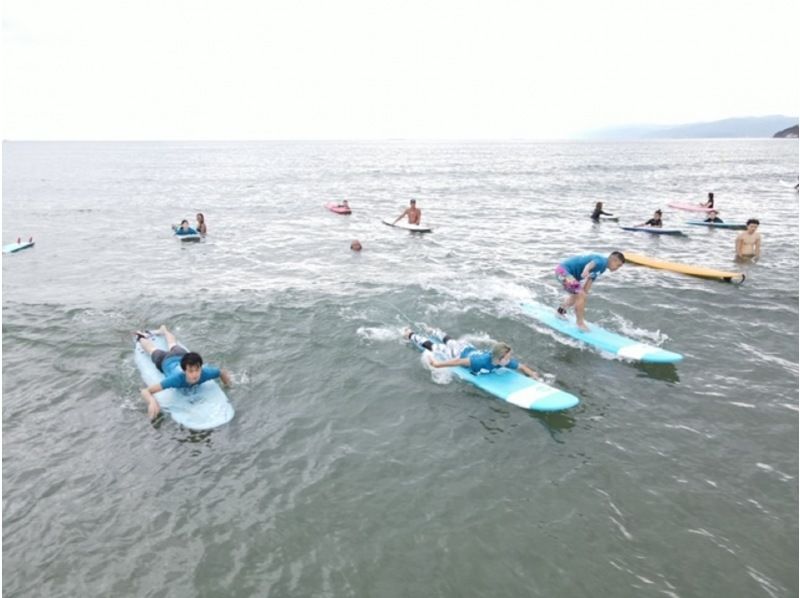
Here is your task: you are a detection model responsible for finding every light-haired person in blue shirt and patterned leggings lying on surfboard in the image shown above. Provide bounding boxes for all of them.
[403,328,542,380]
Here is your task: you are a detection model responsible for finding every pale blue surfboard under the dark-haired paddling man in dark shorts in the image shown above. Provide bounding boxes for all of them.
[133,334,233,430]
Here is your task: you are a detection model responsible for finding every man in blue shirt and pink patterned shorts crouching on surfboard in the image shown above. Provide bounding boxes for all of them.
[556,251,625,332]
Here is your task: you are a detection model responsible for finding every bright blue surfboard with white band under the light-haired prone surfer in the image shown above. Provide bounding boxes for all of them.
[412,336,580,412]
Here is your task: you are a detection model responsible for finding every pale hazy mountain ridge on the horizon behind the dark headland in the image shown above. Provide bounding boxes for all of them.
[583,115,798,140]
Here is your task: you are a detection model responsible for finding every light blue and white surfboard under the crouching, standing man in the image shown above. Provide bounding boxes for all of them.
[522,300,683,364]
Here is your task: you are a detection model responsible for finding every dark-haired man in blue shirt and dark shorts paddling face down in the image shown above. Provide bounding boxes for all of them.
[135,324,231,420]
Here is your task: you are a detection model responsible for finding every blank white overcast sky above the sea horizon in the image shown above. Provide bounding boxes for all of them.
[2,0,800,139]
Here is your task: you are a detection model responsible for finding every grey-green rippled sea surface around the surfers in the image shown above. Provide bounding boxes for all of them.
[2,139,798,598]
